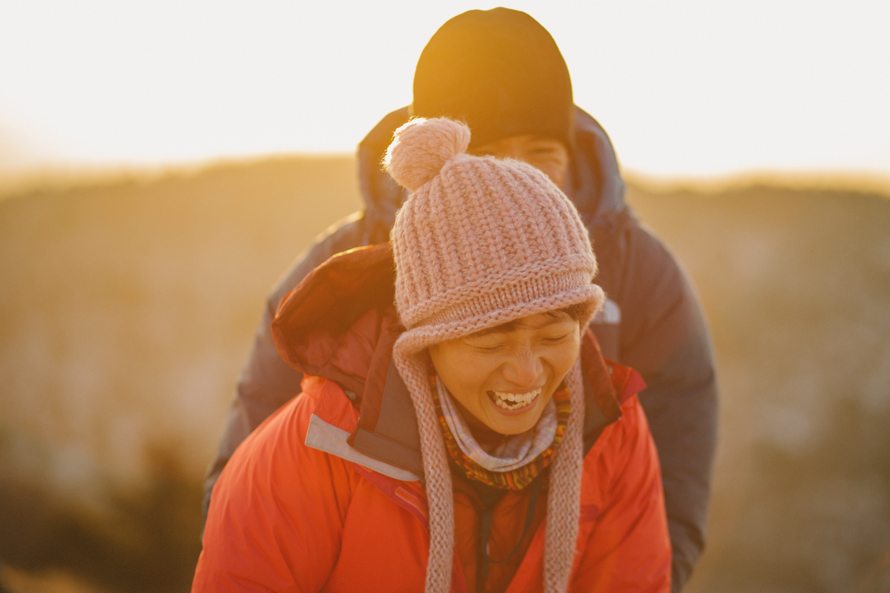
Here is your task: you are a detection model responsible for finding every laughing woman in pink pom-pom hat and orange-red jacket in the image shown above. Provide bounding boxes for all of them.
[193,118,670,593]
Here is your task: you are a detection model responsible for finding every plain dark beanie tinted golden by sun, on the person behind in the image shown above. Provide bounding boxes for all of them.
[411,8,573,150]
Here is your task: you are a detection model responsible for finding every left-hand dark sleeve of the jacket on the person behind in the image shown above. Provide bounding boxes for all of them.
[202,213,369,519]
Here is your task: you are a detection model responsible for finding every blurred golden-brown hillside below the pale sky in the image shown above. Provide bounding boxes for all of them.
[0,158,890,593]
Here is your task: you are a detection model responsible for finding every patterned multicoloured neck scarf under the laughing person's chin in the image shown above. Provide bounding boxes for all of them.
[430,376,572,490]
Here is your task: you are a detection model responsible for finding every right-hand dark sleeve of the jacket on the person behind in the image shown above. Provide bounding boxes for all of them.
[619,221,717,593]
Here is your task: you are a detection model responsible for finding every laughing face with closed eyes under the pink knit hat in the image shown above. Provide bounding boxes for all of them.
[429,311,581,435]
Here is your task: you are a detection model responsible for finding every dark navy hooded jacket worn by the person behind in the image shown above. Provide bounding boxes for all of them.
[204,108,717,593]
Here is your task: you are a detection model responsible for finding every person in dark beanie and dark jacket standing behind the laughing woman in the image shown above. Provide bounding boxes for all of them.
[205,8,717,592]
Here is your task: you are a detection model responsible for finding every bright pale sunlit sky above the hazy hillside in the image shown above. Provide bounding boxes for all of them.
[0,0,890,177]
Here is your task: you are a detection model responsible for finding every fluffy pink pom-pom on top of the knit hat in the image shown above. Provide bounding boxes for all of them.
[383,117,470,192]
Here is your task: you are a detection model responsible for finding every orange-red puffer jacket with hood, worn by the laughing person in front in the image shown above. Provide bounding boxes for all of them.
[192,247,671,593]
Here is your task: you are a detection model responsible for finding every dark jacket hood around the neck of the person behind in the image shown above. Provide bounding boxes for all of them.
[356,106,625,231]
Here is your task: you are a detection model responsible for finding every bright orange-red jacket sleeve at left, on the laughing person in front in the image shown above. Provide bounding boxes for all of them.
[192,388,356,593]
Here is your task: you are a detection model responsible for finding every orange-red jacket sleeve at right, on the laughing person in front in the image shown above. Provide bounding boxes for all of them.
[572,397,671,593]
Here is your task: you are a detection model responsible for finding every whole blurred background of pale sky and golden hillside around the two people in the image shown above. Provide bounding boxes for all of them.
[0,0,890,593]
